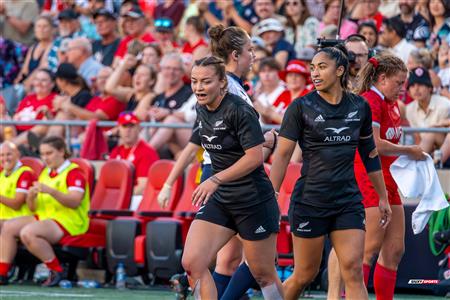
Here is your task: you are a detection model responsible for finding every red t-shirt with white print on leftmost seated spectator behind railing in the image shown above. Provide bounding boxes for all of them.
[14,93,56,131]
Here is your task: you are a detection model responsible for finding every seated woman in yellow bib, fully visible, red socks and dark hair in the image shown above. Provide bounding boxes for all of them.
[0,137,90,287]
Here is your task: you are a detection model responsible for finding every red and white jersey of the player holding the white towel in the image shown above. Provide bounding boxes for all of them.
[361,86,402,169]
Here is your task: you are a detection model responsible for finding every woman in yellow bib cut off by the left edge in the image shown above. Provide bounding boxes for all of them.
[0,142,35,231]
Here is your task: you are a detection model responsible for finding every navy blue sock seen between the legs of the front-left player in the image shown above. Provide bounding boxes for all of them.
[219,262,258,300]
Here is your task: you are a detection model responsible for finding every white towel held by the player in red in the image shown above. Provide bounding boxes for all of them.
[390,154,449,234]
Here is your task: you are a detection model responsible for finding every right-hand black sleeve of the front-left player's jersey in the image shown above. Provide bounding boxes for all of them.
[234,103,264,150]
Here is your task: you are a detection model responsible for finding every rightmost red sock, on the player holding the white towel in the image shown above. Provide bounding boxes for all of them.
[373,263,397,300]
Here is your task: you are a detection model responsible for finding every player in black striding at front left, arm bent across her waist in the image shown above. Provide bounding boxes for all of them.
[182,56,282,299]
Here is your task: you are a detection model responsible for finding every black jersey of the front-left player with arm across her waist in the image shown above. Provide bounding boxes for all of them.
[191,93,274,208]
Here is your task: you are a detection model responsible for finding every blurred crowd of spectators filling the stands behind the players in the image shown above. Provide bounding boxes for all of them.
[0,0,450,173]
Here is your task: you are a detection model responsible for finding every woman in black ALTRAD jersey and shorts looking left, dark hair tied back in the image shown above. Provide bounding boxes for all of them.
[270,47,390,299]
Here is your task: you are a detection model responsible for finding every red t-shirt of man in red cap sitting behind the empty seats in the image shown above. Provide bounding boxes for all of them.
[110,140,159,178]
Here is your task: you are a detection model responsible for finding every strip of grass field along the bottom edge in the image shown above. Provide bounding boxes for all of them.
[0,285,443,300]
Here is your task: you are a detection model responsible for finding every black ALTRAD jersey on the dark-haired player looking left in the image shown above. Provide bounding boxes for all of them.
[280,91,373,207]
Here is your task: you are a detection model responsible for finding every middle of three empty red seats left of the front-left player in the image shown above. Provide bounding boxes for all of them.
[102,159,183,276]
